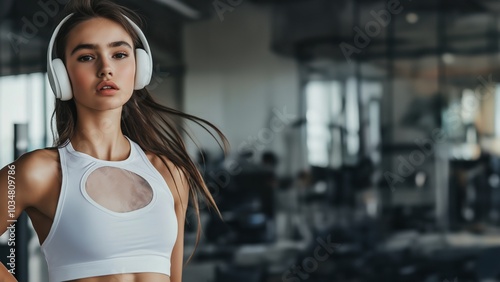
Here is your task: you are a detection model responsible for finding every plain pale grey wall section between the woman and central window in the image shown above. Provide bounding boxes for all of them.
[184,2,299,173]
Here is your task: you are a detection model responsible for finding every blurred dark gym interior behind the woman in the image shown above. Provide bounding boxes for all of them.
[0,0,500,282]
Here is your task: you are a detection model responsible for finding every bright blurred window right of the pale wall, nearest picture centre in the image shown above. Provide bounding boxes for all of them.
[305,78,382,168]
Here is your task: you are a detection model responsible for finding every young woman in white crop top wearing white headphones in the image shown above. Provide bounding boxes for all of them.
[0,0,227,282]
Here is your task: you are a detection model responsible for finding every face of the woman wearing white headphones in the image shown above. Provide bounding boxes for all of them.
[65,18,135,111]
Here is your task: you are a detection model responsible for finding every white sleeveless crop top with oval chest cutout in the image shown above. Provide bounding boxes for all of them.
[41,137,177,282]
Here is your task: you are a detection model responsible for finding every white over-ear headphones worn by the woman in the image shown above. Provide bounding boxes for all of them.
[47,14,153,101]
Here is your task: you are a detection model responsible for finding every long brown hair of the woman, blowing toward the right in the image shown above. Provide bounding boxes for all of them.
[48,0,229,261]
